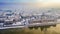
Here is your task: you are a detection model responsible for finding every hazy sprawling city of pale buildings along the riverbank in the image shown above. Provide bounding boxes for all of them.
[0,8,60,29]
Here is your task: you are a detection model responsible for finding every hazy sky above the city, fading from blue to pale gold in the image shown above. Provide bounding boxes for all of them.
[0,0,60,8]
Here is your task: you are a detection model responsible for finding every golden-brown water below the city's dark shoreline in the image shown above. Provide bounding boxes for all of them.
[0,24,60,34]
